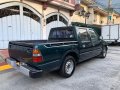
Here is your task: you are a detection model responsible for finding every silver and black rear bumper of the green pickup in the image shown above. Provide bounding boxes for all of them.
[6,58,43,78]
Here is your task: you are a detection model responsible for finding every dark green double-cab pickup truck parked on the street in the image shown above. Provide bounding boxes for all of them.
[6,26,108,78]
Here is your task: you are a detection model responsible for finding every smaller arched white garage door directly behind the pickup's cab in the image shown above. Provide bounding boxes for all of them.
[46,13,68,39]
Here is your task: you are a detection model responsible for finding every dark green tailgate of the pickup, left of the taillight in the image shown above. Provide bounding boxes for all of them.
[9,42,33,63]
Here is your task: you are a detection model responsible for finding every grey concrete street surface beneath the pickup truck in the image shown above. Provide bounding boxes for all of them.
[0,46,120,90]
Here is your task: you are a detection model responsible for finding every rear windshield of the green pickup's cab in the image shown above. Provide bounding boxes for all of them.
[49,28,75,39]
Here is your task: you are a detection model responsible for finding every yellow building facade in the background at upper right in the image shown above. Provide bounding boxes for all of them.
[72,0,120,26]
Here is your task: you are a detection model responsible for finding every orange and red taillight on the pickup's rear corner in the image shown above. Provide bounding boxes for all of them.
[33,49,43,63]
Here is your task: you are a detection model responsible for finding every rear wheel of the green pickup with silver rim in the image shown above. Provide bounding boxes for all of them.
[59,56,76,78]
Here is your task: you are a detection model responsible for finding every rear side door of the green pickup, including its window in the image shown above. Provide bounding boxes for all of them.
[77,28,93,61]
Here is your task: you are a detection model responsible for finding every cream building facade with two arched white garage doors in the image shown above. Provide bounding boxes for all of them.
[0,0,75,49]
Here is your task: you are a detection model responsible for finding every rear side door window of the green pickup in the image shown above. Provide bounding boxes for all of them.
[78,28,90,43]
